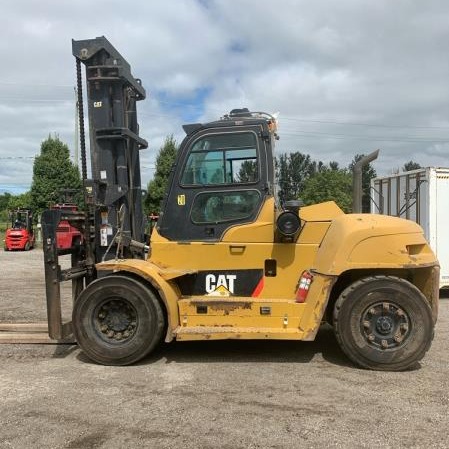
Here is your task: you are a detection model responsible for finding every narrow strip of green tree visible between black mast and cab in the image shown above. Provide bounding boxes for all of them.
[144,135,178,215]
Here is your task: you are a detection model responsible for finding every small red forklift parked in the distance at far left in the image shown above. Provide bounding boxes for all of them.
[5,209,36,251]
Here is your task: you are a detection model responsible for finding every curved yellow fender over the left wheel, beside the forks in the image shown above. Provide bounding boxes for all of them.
[96,259,186,343]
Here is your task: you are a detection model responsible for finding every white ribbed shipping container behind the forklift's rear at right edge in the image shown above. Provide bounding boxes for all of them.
[370,167,449,288]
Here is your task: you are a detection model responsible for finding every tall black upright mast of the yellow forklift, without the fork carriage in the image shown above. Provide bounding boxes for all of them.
[72,37,148,262]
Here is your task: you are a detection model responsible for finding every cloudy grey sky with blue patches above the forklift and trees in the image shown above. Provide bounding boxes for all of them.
[0,0,449,193]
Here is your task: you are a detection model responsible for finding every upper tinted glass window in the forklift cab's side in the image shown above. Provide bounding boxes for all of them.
[181,132,259,186]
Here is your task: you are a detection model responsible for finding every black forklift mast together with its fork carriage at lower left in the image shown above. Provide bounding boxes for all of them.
[42,36,148,339]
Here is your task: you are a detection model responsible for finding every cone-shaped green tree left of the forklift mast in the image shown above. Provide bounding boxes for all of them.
[30,136,82,217]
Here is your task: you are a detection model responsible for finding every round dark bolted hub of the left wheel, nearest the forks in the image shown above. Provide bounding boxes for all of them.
[95,299,137,341]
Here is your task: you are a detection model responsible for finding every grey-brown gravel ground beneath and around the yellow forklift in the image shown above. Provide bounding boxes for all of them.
[0,250,449,449]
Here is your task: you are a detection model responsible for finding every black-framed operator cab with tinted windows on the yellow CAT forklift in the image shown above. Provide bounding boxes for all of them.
[157,109,275,241]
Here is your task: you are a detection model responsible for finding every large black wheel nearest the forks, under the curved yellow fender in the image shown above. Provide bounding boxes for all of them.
[72,276,165,365]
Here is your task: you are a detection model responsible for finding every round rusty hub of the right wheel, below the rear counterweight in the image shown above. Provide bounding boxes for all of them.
[361,301,410,349]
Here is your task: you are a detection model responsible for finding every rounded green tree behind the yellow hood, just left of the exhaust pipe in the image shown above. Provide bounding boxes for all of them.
[301,169,352,212]
